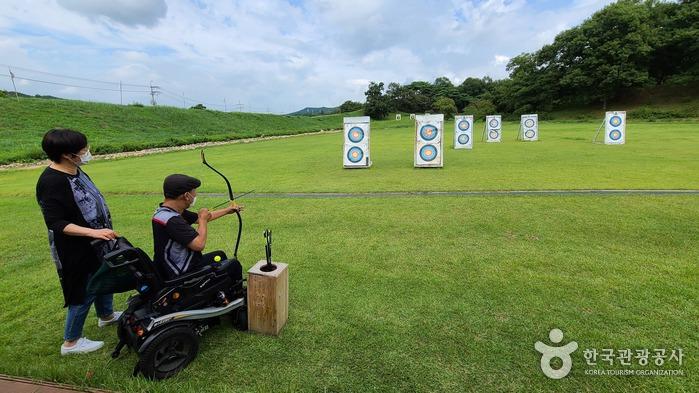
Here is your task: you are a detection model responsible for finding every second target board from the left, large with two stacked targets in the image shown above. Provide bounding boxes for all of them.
[414,115,444,168]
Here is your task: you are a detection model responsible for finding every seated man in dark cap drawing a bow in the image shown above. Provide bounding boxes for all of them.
[152,174,242,280]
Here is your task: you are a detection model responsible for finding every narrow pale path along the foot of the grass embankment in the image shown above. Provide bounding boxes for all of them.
[0,129,341,171]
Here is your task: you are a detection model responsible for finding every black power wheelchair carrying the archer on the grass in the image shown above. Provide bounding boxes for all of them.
[88,237,247,379]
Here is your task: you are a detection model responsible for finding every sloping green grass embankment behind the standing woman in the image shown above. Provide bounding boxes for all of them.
[0,97,342,164]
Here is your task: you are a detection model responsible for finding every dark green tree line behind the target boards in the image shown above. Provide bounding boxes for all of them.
[348,0,699,119]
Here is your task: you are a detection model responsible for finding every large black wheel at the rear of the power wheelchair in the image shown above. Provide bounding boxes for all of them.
[139,327,199,379]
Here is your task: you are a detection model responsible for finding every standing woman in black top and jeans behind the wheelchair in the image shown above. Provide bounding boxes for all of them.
[36,128,121,355]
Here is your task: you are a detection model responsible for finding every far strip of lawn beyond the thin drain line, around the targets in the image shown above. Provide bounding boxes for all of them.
[0,116,699,196]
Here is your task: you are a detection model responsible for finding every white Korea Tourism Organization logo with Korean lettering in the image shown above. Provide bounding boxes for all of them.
[534,328,685,379]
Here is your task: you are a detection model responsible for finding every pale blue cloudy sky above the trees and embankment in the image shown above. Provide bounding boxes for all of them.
[0,0,611,113]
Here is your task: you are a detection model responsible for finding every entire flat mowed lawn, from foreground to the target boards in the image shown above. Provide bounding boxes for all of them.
[0,121,699,392]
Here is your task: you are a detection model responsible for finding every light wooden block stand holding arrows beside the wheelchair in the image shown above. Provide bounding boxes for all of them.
[248,260,289,336]
